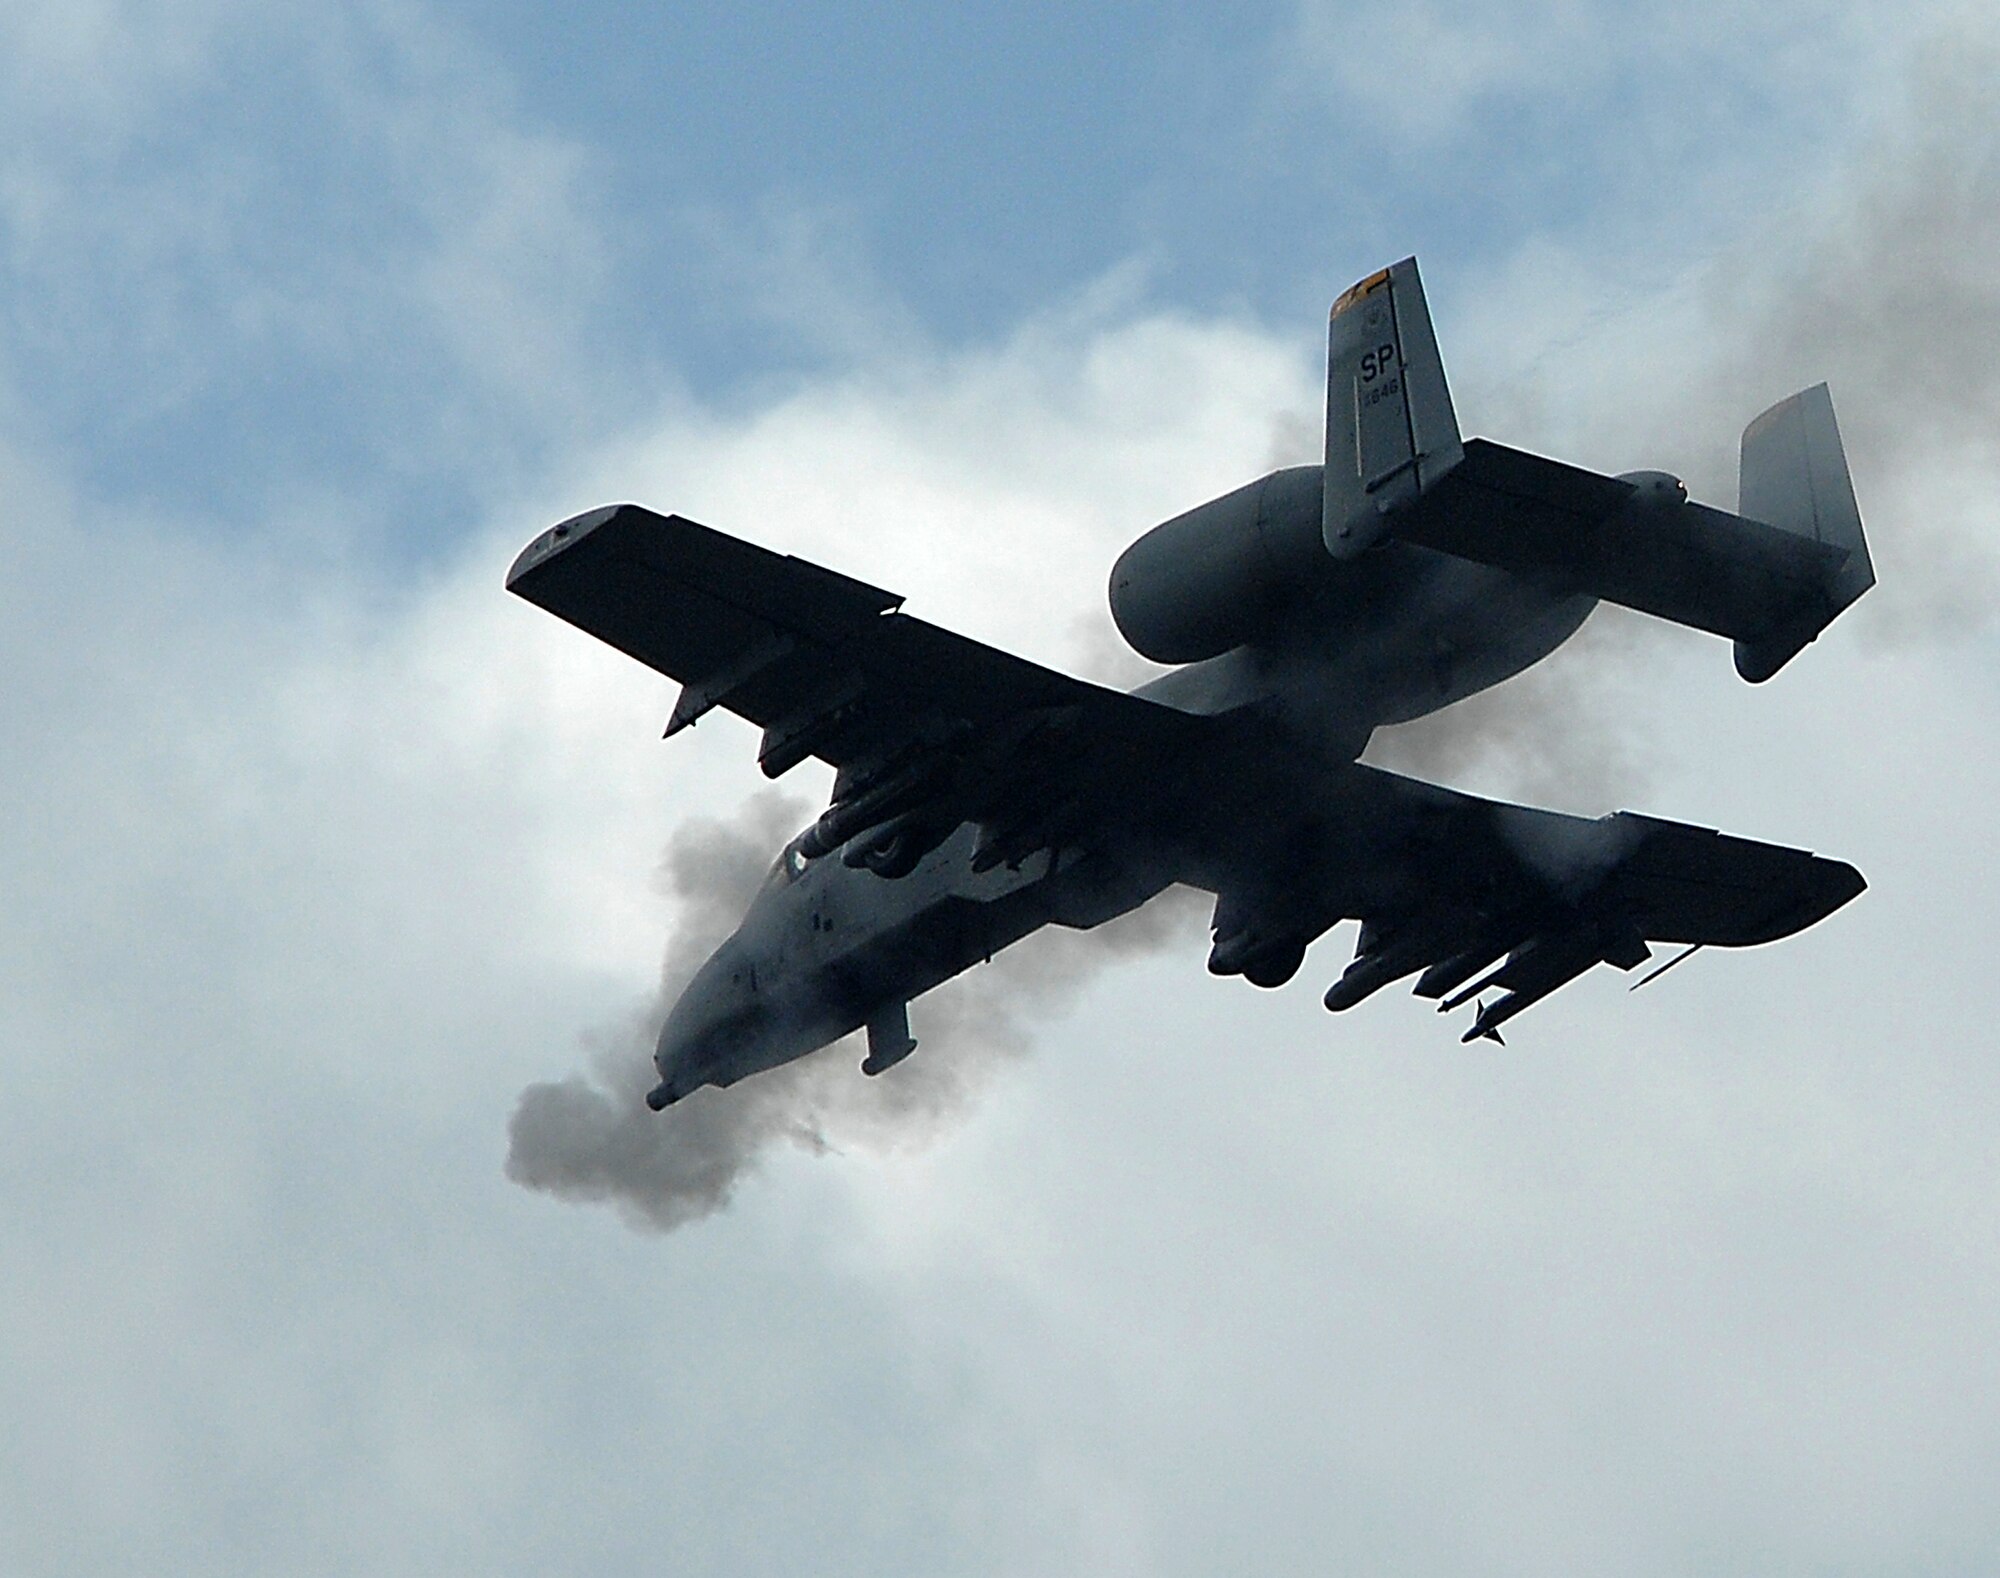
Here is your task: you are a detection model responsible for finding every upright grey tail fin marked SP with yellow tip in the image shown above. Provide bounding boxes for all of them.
[1320,258,1464,558]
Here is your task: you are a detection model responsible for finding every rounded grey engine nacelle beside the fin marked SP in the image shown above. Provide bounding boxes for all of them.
[1110,466,1332,664]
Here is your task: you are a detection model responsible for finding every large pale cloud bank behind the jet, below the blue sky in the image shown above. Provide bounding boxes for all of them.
[0,6,2000,1572]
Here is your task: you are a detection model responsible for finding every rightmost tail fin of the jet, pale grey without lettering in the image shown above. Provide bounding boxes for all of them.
[1736,384,1874,682]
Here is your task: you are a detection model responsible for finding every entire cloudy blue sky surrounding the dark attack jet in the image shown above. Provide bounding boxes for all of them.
[0,0,2000,1576]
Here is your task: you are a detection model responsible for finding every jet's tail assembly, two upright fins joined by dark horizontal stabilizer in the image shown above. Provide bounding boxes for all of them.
[1320,258,1874,682]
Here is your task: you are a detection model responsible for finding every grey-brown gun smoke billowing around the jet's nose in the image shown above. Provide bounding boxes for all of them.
[506,792,1202,1232]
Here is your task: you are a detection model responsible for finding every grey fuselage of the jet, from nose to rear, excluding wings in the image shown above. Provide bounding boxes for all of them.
[652,544,1594,1106]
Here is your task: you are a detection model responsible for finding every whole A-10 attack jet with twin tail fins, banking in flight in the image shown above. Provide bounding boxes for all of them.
[508,258,1874,1108]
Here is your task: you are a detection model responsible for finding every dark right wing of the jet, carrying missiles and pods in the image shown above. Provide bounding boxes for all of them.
[1198,764,1866,1040]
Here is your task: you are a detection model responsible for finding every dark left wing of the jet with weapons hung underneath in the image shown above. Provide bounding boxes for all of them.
[508,504,1202,874]
